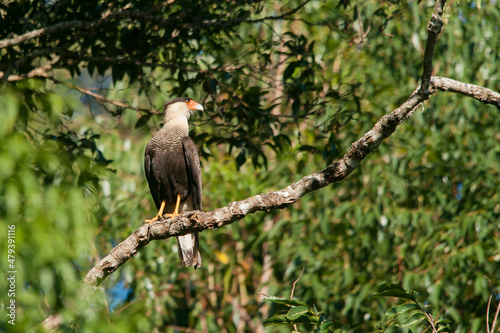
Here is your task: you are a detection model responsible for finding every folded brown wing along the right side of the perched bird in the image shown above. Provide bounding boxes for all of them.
[182,136,202,210]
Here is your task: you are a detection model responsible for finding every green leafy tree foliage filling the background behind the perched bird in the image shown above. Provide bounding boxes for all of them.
[0,0,500,332]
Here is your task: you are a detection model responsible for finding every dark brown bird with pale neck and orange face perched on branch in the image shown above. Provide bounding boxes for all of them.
[144,97,203,269]
